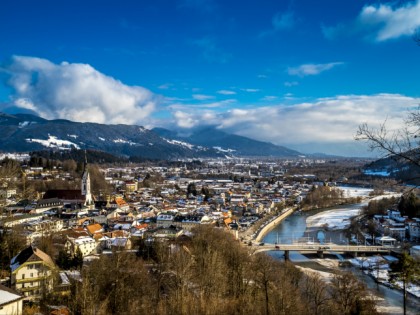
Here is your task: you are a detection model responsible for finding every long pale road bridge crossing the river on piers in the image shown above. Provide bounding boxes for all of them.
[253,243,397,259]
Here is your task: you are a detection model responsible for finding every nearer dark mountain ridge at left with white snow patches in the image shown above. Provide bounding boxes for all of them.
[0,113,227,159]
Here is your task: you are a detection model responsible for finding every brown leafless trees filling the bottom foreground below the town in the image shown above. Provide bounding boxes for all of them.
[36,226,376,315]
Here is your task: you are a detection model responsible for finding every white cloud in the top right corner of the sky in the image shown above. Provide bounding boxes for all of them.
[358,0,420,41]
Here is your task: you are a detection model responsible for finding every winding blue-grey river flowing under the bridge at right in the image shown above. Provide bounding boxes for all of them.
[263,203,420,314]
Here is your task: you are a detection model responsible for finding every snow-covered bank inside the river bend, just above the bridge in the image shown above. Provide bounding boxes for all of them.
[306,208,360,230]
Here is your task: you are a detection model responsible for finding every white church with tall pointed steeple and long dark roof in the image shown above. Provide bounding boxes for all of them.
[42,154,94,208]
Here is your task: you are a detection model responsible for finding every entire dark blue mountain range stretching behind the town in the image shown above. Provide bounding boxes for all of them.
[0,113,302,159]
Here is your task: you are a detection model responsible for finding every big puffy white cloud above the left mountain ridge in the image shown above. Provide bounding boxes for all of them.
[7,56,159,124]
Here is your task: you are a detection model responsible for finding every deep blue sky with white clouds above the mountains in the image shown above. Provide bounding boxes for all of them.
[0,0,420,155]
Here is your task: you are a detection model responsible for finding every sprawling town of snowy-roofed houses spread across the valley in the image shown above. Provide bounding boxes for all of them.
[0,152,420,314]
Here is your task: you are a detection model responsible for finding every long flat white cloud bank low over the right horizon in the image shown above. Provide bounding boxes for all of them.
[174,94,420,155]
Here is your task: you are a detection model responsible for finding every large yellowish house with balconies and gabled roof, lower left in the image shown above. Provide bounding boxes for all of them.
[10,246,56,298]
